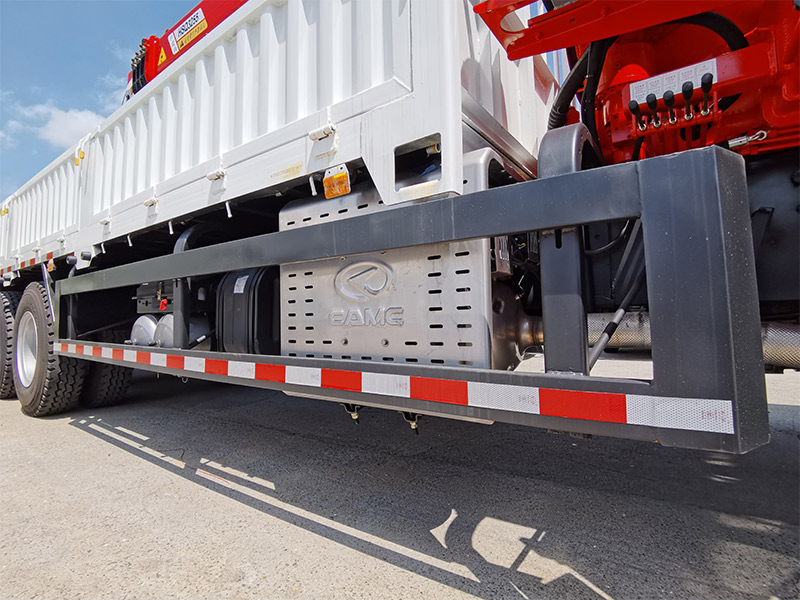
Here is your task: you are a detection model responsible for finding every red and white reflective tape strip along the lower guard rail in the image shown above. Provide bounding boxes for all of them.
[55,343,734,434]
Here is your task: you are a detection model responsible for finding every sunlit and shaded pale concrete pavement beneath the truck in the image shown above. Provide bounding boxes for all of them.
[0,372,800,600]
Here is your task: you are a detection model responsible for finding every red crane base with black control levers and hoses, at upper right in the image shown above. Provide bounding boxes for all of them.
[474,0,800,163]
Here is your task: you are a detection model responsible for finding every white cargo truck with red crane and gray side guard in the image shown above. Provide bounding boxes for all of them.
[0,0,800,453]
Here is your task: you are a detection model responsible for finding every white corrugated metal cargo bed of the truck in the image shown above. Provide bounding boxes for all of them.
[0,0,554,274]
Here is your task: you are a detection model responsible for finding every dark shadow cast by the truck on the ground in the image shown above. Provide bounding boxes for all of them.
[57,374,800,599]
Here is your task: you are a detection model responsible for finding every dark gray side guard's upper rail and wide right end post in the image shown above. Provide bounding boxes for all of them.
[56,147,769,452]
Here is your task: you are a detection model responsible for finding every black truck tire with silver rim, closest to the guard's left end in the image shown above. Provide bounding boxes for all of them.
[13,283,86,417]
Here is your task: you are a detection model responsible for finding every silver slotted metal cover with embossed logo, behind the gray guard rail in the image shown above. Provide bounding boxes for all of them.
[280,191,491,368]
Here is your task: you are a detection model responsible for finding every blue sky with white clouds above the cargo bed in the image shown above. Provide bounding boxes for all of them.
[0,0,199,201]
